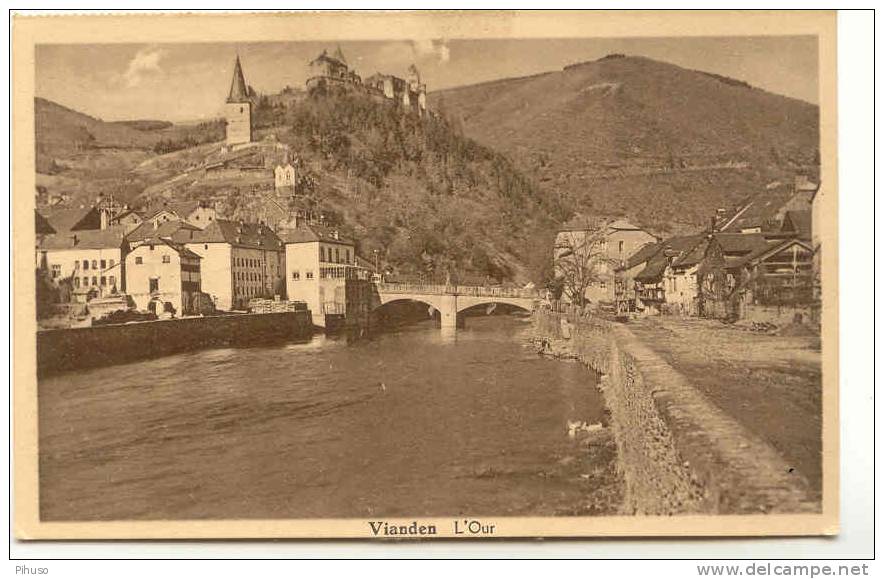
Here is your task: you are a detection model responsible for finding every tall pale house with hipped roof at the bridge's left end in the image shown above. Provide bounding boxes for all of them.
[280,223,370,327]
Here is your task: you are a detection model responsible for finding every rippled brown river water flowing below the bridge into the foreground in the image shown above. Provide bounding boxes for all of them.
[39,316,620,520]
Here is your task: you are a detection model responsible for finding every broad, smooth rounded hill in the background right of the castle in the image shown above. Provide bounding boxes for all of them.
[430,55,819,232]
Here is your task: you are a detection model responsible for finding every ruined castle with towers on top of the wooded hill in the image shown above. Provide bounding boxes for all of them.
[306,46,427,115]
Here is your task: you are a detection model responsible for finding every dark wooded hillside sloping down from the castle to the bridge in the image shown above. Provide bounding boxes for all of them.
[256,92,569,281]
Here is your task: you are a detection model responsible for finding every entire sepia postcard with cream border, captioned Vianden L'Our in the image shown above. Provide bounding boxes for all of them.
[12,12,839,539]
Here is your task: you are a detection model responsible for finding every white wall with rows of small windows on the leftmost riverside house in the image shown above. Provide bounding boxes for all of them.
[37,248,126,294]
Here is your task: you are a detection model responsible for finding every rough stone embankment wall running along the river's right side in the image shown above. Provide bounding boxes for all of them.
[536,312,820,514]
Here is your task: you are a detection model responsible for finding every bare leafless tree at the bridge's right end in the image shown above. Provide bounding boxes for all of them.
[553,222,607,307]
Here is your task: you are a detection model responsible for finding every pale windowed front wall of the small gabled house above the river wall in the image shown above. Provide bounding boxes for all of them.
[126,244,184,316]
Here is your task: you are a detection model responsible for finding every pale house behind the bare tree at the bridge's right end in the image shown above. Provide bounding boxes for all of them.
[553,216,657,304]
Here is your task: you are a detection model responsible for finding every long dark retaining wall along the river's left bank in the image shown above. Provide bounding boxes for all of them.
[37,311,313,376]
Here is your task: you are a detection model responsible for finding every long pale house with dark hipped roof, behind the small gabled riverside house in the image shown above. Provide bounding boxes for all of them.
[172,219,285,311]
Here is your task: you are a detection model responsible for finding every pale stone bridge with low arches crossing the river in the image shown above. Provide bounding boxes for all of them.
[374,283,540,328]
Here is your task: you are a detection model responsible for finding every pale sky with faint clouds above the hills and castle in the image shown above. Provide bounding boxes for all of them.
[36,36,819,121]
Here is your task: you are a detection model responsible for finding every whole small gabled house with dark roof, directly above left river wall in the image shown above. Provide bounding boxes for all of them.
[126,237,201,316]
